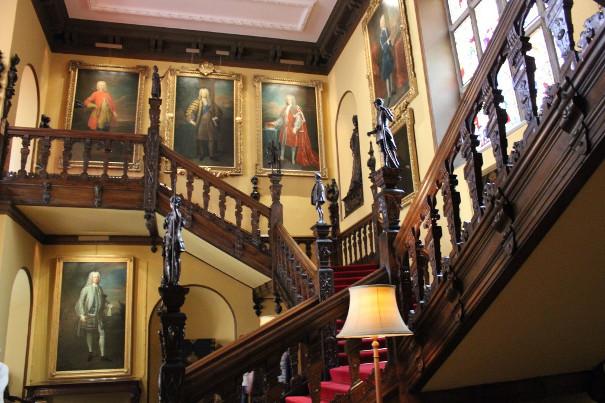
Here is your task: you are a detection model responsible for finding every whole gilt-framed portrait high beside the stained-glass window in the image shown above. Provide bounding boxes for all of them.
[362,0,418,120]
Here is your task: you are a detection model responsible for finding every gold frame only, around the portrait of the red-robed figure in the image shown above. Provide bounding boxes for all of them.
[253,76,328,179]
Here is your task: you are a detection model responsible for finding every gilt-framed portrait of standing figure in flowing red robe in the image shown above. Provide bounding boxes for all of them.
[254,76,327,178]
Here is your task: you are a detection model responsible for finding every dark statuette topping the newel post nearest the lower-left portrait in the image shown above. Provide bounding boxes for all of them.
[162,195,185,287]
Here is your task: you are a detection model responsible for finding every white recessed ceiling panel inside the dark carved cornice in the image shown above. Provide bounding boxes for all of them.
[65,0,337,42]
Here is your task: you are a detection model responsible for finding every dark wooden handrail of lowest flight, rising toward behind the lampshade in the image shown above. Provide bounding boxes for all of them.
[183,270,387,402]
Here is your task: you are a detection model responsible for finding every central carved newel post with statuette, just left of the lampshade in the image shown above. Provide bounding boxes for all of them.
[311,176,338,379]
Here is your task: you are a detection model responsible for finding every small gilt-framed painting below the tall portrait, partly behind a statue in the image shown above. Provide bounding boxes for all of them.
[391,108,420,206]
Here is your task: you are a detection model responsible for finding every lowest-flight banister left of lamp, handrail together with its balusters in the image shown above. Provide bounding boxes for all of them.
[183,270,387,402]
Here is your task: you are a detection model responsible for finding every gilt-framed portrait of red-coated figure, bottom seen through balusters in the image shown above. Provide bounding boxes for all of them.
[64,60,149,170]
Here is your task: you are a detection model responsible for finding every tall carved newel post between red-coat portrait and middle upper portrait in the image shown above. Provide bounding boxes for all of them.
[143,66,162,252]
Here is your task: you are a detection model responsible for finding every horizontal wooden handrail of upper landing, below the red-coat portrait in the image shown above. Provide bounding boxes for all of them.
[6,126,147,144]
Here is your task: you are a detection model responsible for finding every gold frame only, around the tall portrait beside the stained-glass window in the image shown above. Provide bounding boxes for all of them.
[362,0,418,124]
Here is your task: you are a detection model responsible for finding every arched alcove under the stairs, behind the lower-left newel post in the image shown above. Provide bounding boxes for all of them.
[147,284,237,402]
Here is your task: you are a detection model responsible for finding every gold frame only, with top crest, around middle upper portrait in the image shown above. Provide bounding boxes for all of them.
[162,62,244,177]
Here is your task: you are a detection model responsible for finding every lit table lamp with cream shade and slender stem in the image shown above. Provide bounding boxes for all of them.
[336,284,413,403]
